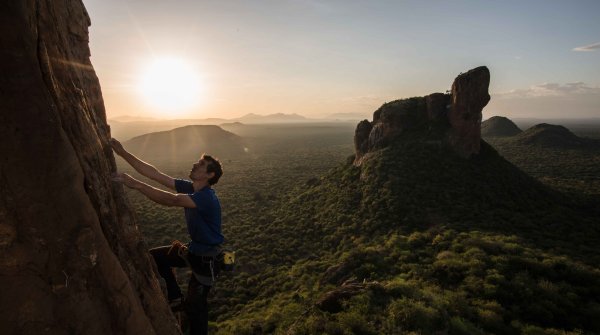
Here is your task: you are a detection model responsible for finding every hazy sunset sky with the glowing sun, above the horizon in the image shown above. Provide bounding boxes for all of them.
[83,0,600,119]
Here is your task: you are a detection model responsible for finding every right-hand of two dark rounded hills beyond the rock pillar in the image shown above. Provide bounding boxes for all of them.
[514,123,596,148]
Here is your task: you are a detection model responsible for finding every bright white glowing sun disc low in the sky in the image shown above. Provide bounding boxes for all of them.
[139,58,202,114]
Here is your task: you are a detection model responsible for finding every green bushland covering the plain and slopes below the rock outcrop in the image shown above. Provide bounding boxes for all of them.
[113,125,600,334]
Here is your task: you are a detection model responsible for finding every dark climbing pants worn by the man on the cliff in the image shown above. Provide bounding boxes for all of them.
[150,245,210,335]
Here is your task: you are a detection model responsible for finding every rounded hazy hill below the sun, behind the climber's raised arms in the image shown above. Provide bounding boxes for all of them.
[124,125,244,160]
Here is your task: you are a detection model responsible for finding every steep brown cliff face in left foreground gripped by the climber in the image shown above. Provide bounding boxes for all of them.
[0,0,179,334]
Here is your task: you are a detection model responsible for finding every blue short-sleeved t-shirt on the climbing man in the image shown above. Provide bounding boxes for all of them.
[175,179,224,255]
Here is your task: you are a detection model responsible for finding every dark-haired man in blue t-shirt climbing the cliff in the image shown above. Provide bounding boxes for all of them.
[110,139,224,334]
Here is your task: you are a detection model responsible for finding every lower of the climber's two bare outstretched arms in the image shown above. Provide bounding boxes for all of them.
[112,173,196,208]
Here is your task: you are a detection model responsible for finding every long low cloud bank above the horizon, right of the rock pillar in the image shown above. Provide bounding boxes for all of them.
[494,82,600,99]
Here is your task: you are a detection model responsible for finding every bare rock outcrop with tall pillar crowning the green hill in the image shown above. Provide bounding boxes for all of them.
[354,66,490,165]
